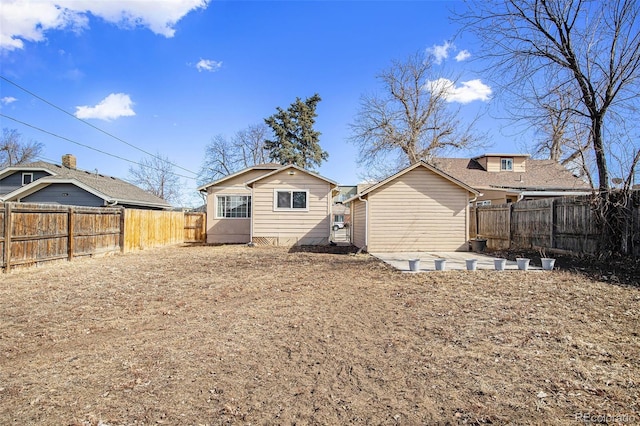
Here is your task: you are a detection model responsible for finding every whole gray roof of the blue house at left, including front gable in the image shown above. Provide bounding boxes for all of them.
[0,161,171,208]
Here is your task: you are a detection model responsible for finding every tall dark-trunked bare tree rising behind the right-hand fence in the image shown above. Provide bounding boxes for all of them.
[458,0,640,191]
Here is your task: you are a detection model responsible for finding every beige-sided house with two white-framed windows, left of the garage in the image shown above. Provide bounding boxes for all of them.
[198,163,337,246]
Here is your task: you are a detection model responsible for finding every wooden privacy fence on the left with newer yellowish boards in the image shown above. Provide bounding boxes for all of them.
[0,203,206,272]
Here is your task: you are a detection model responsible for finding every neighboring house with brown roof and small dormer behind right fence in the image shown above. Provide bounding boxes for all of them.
[432,154,591,205]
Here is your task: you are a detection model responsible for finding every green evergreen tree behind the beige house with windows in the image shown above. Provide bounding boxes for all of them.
[264,93,329,169]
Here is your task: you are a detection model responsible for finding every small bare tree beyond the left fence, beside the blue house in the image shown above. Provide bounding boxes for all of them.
[129,154,181,204]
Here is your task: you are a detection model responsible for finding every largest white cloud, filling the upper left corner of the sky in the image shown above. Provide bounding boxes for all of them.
[0,0,210,50]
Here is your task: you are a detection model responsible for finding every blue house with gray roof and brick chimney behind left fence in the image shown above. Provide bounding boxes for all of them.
[0,154,171,210]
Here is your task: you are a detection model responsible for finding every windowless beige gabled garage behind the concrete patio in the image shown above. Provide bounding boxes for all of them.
[347,161,478,252]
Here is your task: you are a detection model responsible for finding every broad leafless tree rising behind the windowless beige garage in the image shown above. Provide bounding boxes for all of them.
[350,53,480,178]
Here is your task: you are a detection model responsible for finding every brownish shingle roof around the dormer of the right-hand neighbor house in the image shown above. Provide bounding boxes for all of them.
[431,157,591,191]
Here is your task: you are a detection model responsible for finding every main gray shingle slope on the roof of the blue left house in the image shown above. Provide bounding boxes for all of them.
[18,161,171,208]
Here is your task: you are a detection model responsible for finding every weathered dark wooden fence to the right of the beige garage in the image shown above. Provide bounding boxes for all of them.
[469,193,640,255]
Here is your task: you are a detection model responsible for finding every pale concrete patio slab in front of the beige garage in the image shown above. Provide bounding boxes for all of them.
[370,252,542,272]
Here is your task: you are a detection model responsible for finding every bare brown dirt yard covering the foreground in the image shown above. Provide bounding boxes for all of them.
[0,246,640,425]
